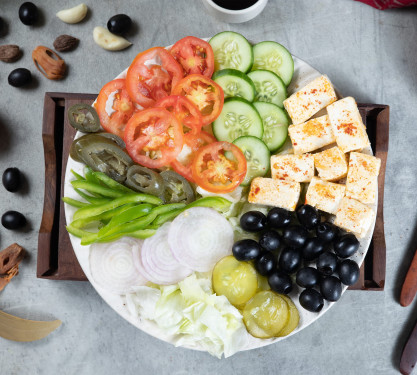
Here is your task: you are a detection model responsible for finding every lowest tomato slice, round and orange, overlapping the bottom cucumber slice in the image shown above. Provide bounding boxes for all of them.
[191,142,247,193]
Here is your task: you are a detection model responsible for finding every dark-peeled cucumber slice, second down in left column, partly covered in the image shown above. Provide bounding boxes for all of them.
[211,69,255,102]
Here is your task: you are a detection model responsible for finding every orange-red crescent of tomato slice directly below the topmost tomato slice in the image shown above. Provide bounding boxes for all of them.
[172,74,224,126]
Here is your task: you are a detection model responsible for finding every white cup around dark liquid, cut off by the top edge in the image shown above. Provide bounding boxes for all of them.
[202,0,268,23]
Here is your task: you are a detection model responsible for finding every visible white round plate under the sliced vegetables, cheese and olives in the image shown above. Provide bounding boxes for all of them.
[64,41,377,356]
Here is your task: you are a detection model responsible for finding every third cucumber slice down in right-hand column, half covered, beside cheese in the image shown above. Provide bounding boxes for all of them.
[253,102,289,152]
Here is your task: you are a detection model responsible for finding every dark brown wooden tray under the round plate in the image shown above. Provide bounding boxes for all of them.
[37,93,389,290]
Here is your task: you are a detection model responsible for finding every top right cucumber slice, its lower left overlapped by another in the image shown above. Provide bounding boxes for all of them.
[252,42,294,86]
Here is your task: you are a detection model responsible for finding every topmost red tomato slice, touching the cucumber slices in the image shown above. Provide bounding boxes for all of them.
[171,36,214,78]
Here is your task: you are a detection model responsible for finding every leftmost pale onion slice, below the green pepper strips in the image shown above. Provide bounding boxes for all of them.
[89,237,148,294]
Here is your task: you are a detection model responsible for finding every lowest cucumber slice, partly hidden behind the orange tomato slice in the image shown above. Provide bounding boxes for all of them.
[233,135,271,186]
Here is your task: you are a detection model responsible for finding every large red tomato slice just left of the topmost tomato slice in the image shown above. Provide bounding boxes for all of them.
[126,47,184,108]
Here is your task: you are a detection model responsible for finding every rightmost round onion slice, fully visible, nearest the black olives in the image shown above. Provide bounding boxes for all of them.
[168,207,234,272]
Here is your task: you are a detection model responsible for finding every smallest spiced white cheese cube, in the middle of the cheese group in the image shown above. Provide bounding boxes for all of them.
[314,147,348,181]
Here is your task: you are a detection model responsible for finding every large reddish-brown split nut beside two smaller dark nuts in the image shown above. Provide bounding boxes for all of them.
[32,46,67,79]
